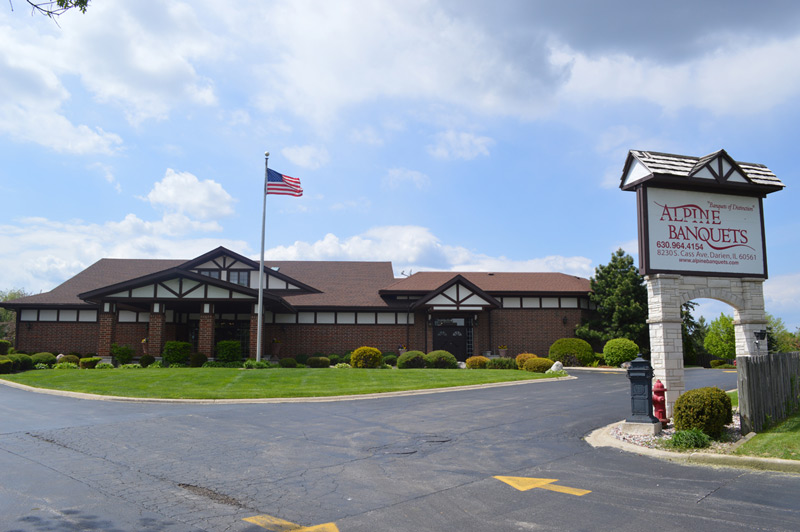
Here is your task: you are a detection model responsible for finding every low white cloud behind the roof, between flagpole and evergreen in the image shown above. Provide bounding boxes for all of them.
[266,225,593,277]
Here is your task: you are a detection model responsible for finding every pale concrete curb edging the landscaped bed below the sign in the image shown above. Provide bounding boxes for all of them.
[584,421,800,475]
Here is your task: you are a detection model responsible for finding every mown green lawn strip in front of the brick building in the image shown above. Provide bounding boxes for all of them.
[2,368,560,399]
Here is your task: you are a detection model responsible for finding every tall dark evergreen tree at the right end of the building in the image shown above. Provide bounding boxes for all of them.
[575,249,650,352]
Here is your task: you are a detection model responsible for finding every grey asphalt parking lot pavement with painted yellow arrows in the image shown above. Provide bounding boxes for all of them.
[0,370,800,532]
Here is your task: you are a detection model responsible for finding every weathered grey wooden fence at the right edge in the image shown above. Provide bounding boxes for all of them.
[736,353,800,434]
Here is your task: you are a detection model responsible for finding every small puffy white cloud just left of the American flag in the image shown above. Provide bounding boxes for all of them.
[146,168,235,220]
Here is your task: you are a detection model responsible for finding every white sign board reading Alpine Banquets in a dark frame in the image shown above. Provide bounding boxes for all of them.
[639,186,767,277]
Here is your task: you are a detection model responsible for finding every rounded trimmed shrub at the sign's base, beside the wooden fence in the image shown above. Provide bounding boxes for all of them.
[673,387,733,439]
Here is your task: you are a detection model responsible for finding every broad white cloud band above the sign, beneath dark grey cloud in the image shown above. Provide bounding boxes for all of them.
[553,35,800,115]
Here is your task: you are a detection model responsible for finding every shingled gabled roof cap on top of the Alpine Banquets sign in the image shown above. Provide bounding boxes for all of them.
[620,150,785,196]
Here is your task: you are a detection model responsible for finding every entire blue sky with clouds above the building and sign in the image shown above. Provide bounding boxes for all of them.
[0,0,800,330]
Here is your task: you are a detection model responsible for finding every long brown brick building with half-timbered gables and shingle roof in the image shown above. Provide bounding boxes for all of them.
[2,247,590,360]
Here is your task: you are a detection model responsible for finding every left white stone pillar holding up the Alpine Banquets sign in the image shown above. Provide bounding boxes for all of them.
[645,274,686,417]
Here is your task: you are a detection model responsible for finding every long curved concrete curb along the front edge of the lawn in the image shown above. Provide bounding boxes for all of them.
[0,375,578,405]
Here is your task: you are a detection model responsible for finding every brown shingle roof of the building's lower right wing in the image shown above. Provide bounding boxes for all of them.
[384,272,591,294]
